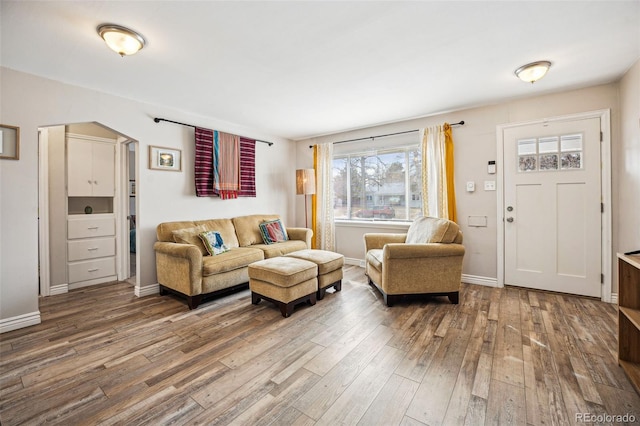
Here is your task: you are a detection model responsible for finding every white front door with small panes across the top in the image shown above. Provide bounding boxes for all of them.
[502,118,602,297]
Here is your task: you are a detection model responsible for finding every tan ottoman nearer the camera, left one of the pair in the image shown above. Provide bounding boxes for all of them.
[249,256,318,318]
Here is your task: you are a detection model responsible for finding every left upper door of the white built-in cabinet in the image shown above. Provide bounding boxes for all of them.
[67,138,93,197]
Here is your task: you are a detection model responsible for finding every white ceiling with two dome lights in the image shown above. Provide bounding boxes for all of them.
[0,0,640,140]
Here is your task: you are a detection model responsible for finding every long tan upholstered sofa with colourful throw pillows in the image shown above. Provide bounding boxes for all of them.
[153,215,313,309]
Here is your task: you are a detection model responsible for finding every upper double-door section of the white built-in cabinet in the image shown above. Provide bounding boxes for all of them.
[67,137,116,197]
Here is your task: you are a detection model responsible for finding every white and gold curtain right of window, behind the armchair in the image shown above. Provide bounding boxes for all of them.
[421,123,457,222]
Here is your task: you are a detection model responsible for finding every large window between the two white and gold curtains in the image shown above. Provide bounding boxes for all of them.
[333,144,422,221]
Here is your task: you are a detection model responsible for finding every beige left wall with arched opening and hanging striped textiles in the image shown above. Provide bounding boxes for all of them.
[0,68,295,330]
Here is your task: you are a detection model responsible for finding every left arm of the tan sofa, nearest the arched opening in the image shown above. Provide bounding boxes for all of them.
[153,241,202,296]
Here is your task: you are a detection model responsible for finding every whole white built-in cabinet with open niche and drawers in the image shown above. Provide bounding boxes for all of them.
[66,134,117,289]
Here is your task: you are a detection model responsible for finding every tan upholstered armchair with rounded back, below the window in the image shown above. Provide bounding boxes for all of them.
[364,217,464,306]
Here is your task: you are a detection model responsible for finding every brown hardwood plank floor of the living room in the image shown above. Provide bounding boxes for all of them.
[0,266,640,426]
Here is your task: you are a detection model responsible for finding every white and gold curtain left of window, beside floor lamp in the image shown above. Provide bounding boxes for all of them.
[311,143,336,251]
